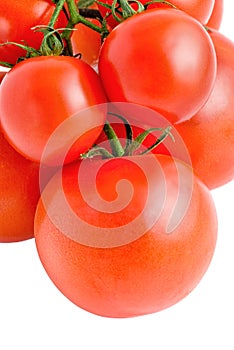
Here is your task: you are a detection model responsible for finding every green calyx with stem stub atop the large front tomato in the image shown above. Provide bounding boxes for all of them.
[81,112,175,159]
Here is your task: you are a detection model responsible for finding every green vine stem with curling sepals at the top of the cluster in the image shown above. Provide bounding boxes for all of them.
[0,0,175,68]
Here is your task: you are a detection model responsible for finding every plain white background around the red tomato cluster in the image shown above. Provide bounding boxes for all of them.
[0,0,234,350]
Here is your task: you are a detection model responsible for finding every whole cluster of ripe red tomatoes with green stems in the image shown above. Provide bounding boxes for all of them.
[0,0,231,317]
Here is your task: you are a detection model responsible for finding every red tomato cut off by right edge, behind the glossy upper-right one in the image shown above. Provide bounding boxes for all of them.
[175,31,234,189]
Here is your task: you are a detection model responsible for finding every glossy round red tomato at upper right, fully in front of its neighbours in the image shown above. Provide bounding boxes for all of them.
[99,9,216,122]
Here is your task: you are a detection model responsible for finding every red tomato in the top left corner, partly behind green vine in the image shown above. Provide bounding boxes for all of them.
[0,0,66,64]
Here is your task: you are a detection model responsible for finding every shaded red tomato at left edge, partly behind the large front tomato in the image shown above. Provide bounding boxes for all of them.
[0,130,40,242]
